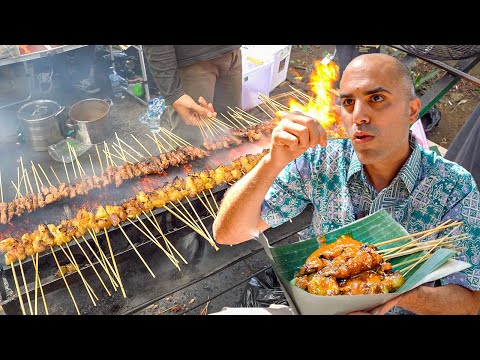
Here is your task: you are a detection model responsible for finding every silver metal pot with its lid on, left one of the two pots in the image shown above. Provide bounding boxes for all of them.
[17,100,65,151]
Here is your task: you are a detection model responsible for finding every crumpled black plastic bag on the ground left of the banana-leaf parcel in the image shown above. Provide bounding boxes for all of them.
[242,268,288,307]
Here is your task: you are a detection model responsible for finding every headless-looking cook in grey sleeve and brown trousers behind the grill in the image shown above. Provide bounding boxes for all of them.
[144,45,242,145]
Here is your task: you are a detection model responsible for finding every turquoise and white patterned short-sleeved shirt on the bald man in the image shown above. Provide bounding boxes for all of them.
[261,135,480,290]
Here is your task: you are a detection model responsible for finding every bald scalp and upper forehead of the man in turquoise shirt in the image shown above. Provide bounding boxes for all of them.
[340,53,416,100]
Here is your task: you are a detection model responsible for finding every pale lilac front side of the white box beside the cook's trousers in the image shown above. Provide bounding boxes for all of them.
[242,56,272,110]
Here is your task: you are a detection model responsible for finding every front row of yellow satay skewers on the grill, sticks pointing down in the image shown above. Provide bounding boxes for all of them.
[0,150,267,314]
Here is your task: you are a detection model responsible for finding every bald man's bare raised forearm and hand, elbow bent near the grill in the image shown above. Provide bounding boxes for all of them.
[213,113,327,244]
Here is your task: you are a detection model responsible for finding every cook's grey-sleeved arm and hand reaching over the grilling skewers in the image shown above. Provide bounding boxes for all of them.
[144,45,217,126]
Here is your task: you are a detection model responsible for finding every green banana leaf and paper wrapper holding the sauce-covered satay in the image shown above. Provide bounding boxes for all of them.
[258,210,471,315]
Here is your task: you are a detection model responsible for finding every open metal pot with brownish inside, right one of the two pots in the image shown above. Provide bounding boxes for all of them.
[66,99,113,145]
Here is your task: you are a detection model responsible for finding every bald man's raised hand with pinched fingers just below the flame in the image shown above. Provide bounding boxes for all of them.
[270,112,327,168]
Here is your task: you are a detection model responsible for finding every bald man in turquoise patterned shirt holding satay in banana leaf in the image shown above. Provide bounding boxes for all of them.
[213,54,480,314]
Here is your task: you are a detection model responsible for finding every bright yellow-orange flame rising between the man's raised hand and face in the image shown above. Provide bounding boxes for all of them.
[289,57,340,130]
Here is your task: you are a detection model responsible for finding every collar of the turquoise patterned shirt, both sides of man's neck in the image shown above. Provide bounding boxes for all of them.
[347,132,421,192]
